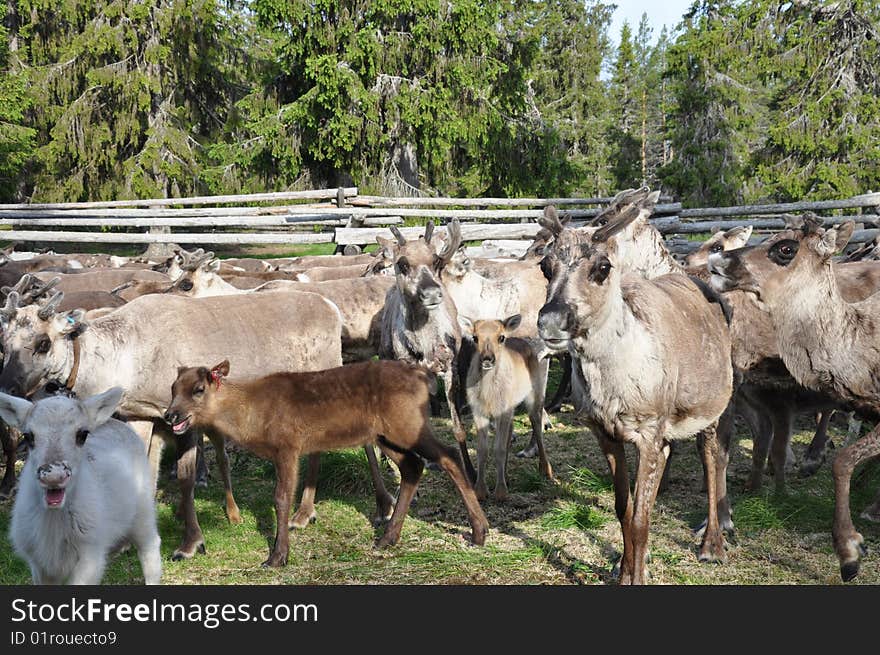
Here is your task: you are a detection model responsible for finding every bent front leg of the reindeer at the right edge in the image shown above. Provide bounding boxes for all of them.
[832,425,880,582]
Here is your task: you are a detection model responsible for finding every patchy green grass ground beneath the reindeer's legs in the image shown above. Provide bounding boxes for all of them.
[0,364,880,584]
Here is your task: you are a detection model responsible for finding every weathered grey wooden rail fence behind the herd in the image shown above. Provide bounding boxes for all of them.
[0,187,880,252]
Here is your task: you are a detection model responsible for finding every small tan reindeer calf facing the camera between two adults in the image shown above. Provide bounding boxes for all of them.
[458,314,553,501]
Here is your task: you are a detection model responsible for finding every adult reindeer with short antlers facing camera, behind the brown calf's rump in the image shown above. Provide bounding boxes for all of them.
[379,220,476,480]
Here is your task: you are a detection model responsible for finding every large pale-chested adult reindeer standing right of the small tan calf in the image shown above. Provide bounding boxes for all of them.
[538,198,733,584]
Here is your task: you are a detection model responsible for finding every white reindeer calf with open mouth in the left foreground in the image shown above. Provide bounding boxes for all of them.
[0,387,162,584]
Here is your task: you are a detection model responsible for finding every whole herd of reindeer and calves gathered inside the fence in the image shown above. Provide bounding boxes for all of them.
[0,189,880,584]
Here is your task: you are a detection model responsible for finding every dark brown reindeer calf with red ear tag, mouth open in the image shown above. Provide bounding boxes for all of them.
[165,361,489,566]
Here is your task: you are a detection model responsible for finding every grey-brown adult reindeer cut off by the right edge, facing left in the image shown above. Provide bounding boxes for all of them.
[714,217,880,581]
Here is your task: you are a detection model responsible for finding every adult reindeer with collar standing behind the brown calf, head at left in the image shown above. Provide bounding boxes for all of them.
[0,292,342,558]
